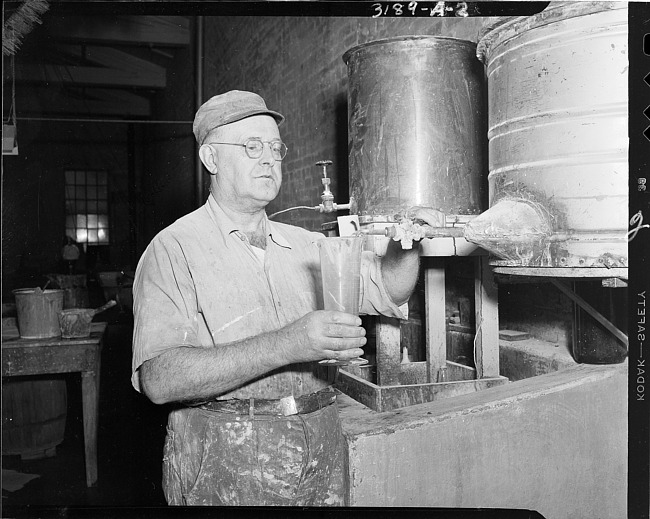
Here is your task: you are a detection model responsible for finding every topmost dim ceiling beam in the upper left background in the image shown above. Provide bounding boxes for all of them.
[48,16,190,47]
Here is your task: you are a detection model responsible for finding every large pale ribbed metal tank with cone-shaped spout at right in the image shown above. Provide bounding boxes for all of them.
[465,2,628,277]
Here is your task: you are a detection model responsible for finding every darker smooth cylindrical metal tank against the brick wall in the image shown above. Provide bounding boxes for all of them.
[343,36,487,223]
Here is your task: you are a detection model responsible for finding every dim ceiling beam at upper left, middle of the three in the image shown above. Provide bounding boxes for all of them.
[16,65,167,89]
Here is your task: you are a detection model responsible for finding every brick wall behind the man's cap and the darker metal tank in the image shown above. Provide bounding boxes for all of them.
[204,17,483,230]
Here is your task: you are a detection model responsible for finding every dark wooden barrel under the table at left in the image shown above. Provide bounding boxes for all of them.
[2,379,68,459]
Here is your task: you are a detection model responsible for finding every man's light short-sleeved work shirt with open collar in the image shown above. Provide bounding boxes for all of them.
[131,195,404,399]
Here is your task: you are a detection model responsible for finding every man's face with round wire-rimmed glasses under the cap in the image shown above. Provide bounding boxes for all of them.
[206,115,282,211]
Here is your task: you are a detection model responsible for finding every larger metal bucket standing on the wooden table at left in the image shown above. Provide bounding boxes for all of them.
[13,288,64,339]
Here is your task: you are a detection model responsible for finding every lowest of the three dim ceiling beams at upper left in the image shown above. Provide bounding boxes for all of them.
[16,87,151,119]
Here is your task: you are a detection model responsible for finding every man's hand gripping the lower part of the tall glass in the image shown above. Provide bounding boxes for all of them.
[279,310,366,363]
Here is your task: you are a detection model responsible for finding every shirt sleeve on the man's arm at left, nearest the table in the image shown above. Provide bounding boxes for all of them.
[131,235,199,391]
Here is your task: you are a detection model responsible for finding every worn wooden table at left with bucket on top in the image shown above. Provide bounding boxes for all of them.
[2,319,106,487]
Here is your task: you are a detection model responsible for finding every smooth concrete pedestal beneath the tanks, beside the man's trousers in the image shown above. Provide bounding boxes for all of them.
[339,363,627,519]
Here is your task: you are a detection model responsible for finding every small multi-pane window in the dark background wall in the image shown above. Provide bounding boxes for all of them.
[65,170,109,245]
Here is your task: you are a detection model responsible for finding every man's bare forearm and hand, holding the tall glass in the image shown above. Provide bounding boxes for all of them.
[139,310,366,404]
